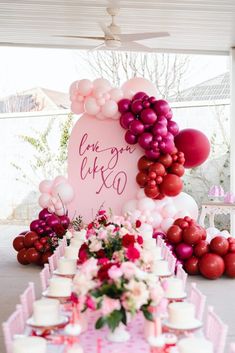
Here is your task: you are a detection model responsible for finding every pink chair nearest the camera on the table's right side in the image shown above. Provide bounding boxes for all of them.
[205,306,228,353]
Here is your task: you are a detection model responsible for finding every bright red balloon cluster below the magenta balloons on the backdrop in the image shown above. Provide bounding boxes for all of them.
[136,148,185,200]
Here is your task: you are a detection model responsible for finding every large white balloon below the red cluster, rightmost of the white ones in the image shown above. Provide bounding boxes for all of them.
[172,192,198,220]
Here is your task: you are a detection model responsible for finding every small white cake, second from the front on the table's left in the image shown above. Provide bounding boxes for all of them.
[33,298,60,326]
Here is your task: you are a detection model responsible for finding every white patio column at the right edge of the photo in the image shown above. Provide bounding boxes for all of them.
[230,48,235,237]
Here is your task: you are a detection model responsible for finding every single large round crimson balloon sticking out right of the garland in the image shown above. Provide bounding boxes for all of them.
[174,129,210,168]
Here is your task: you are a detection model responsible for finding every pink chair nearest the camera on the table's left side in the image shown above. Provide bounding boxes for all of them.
[2,305,25,353]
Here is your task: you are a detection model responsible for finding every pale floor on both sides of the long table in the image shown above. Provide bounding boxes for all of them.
[0,226,235,353]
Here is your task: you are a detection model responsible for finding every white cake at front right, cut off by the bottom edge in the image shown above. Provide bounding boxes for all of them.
[177,337,213,353]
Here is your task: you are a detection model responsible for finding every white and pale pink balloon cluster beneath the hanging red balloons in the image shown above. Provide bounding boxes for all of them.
[122,189,198,232]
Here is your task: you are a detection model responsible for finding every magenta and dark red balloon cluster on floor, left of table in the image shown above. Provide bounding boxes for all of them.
[13,209,70,265]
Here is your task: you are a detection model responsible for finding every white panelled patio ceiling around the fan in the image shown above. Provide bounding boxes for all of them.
[0,0,235,55]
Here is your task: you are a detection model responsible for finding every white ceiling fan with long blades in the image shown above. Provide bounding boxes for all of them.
[56,6,170,51]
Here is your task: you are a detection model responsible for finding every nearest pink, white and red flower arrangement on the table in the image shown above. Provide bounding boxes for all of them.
[74,258,163,331]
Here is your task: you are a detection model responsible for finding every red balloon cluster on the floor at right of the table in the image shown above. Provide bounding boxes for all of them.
[166,217,235,279]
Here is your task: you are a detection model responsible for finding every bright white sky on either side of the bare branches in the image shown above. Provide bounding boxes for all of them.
[0,47,229,96]
